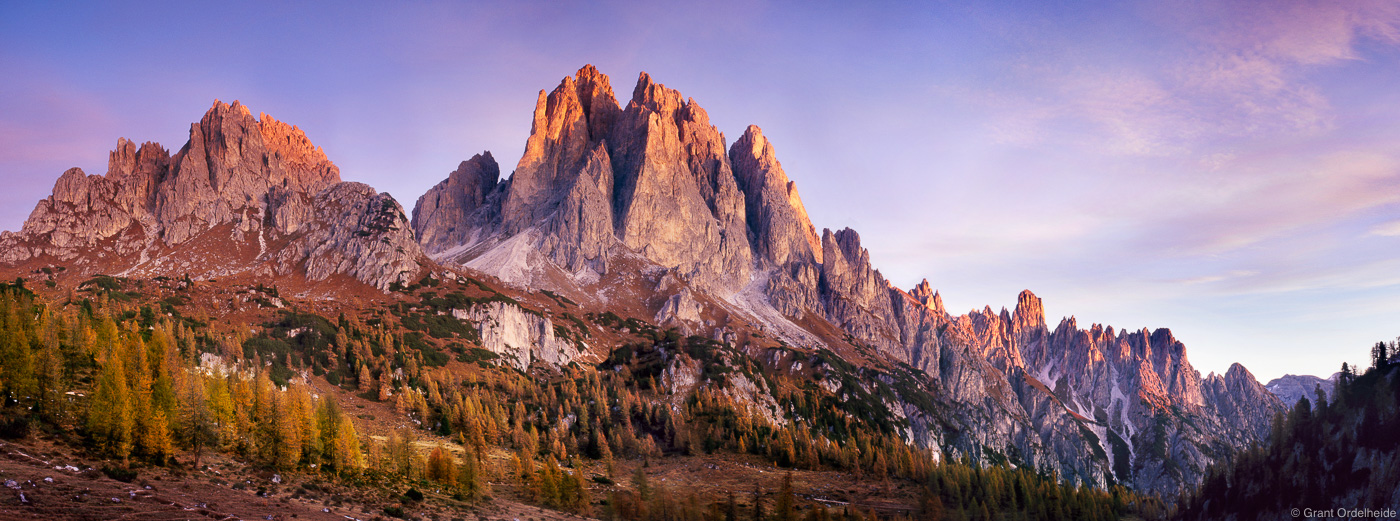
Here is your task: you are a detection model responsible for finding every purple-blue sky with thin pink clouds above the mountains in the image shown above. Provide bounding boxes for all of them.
[0,0,1400,382]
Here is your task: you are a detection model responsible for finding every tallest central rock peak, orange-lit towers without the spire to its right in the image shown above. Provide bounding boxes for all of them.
[416,66,753,294]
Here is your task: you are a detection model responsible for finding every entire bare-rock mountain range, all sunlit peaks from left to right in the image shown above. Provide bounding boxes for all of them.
[0,66,1310,494]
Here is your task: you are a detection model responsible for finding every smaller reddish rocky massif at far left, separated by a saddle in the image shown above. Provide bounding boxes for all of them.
[0,101,421,289]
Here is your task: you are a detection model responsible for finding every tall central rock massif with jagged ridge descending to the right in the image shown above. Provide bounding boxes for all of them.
[403,66,1280,493]
